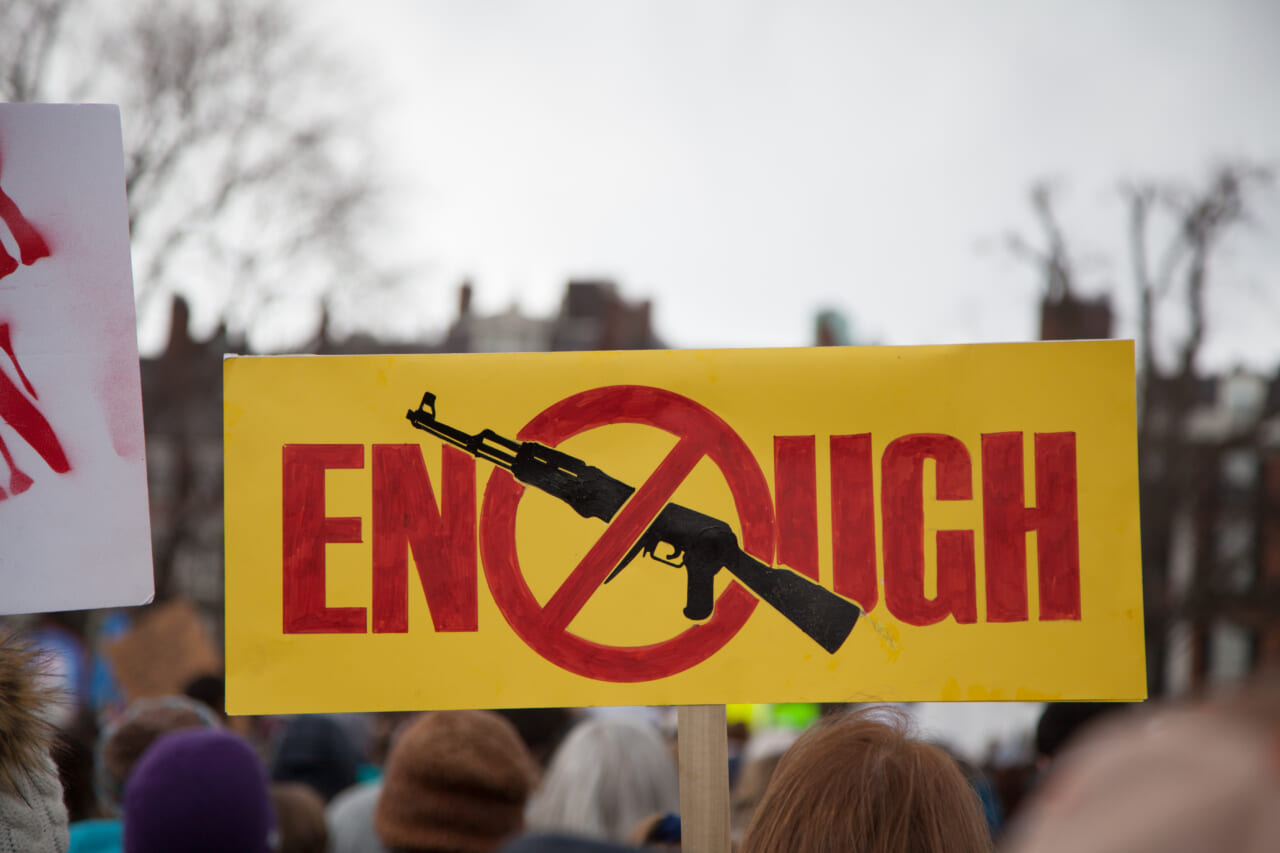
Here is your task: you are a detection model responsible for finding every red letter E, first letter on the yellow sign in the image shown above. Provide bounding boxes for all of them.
[282,444,365,634]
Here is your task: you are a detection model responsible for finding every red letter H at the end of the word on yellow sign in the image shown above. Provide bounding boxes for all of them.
[982,433,1080,622]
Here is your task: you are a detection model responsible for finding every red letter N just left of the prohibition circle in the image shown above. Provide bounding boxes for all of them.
[374,444,479,633]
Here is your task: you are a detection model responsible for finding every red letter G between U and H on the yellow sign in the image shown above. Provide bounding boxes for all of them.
[881,433,978,625]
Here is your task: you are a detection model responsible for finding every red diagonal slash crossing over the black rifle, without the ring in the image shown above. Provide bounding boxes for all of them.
[543,437,707,630]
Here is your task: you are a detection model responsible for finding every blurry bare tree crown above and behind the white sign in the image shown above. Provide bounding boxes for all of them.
[0,0,384,348]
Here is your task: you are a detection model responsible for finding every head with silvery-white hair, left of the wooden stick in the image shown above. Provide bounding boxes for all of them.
[529,713,680,841]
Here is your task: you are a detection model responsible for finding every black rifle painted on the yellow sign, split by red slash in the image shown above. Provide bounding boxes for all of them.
[407,392,861,653]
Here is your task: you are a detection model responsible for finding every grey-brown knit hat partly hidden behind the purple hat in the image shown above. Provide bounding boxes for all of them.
[95,695,219,815]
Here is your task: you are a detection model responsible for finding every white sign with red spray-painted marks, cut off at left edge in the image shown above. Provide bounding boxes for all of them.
[0,104,154,613]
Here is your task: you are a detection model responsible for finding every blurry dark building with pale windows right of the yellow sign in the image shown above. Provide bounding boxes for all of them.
[1140,370,1280,695]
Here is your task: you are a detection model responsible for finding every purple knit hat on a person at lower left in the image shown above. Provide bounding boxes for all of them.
[123,729,275,853]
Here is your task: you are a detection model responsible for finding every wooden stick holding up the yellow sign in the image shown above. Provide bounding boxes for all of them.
[677,704,731,853]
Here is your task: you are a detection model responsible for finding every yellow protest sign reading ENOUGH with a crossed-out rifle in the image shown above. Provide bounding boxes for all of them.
[224,342,1146,713]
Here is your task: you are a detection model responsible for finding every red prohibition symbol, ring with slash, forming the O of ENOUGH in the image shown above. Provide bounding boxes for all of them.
[480,386,774,681]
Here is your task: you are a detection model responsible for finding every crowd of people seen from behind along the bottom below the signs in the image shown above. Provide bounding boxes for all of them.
[0,625,1280,853]
